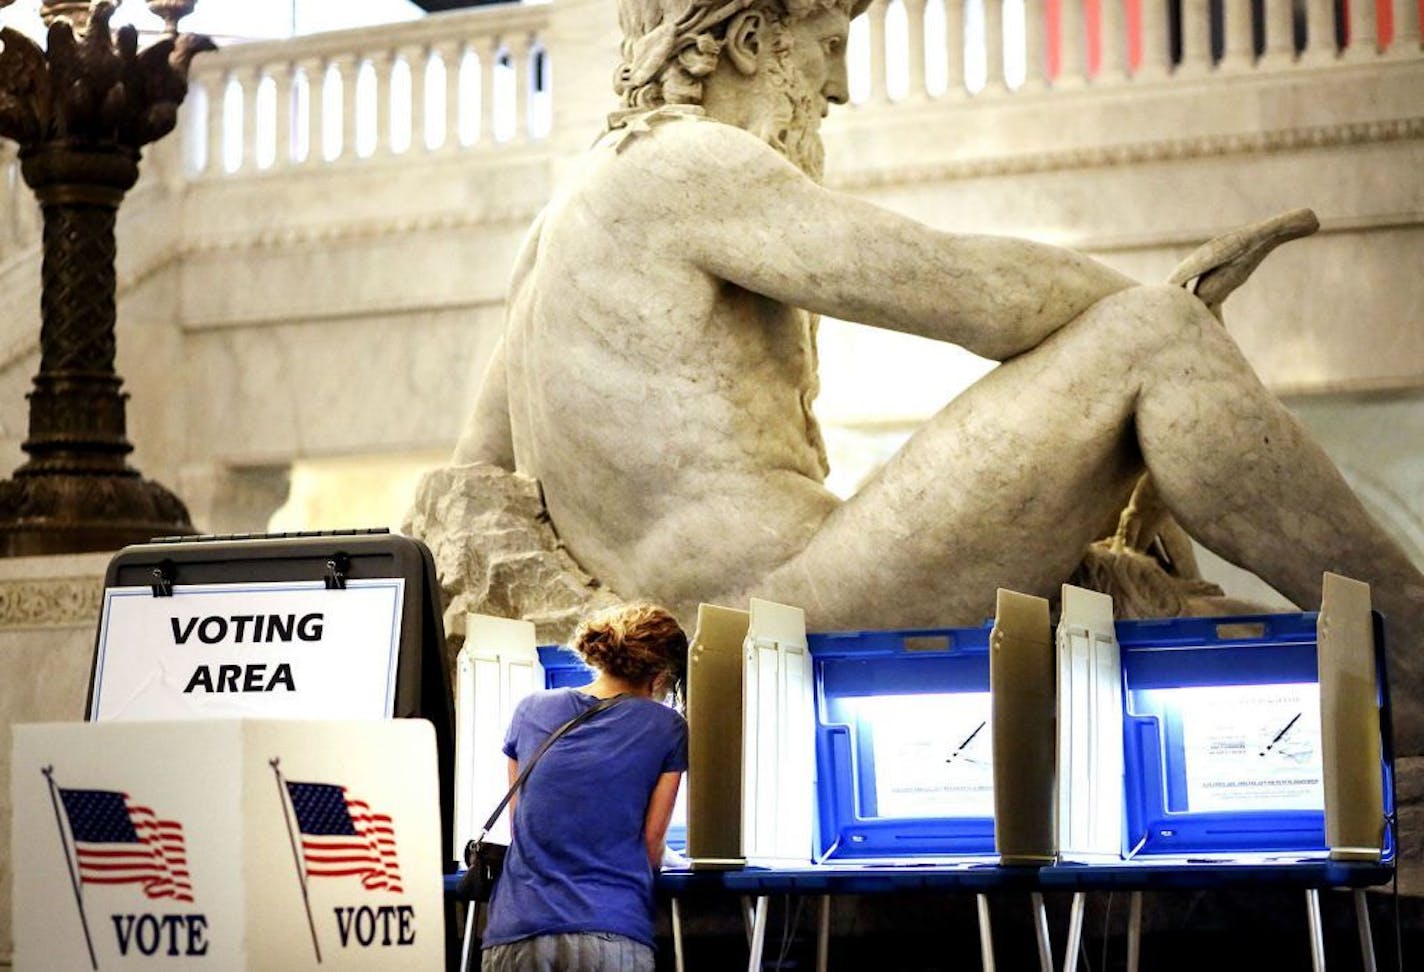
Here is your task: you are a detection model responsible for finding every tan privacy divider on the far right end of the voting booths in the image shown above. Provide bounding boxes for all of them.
[1316,574,1384,861]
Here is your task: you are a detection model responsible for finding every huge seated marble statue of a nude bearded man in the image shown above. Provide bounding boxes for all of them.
[438,0,1424,753]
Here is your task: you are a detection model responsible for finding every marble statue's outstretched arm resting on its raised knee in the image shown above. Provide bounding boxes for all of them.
[652,124,1134,360]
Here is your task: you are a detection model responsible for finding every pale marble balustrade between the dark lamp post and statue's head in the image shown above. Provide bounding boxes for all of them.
[184,4,550,176]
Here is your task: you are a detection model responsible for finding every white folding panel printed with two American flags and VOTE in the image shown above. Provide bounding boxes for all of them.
[10,720,444,972]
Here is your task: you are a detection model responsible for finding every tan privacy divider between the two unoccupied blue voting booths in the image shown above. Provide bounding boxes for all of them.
[988,588,1055,864]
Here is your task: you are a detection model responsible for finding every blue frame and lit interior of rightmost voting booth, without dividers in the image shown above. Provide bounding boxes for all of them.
[1116,612,1394,864]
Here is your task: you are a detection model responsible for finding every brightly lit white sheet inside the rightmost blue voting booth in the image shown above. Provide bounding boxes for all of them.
[1161,683,1324,813]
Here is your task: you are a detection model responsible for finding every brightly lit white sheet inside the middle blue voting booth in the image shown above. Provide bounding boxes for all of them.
[857,692,994,818]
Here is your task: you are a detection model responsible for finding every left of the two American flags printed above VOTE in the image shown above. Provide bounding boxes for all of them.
[60,787,192,901]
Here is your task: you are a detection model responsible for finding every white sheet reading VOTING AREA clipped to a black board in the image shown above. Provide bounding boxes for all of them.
[90,578,406,722]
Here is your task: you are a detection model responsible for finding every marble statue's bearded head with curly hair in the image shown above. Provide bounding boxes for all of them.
[614,0,870,178]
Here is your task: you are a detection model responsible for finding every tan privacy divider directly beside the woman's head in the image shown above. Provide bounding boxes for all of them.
[688,603,750,867]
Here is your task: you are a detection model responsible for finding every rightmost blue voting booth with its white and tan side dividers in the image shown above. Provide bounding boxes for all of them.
[1058,575,1394,864]
